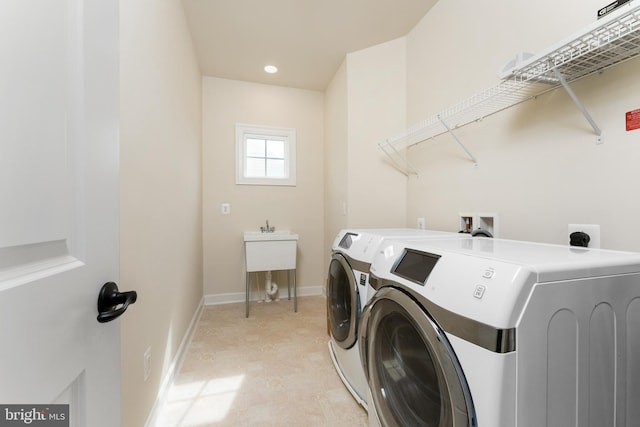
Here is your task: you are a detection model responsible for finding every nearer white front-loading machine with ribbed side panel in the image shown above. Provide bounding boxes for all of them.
[359,239,640,427]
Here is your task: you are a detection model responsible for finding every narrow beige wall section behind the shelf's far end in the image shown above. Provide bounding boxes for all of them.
[346,37,406,227]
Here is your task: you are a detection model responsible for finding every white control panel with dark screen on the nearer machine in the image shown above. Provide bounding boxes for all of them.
[371,242,536,328]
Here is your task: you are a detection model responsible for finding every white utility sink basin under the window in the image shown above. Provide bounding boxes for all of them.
[244,230,298,273]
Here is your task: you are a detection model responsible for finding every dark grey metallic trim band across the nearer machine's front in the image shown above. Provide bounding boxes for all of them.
[369,273,516,353]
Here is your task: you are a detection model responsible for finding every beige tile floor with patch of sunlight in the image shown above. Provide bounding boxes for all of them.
[156,296,367,427]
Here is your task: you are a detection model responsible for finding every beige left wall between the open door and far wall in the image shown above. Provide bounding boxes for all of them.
[119,0,202,427]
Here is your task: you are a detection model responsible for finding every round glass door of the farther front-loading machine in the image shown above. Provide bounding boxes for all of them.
[327,253,360,349]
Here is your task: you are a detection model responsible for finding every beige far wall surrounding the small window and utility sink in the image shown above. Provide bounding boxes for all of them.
[203,77,324,303]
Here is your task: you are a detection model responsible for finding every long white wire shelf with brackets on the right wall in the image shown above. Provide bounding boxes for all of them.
[378,0,640,175]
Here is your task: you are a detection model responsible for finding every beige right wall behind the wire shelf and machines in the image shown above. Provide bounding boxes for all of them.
[407,0,640,250]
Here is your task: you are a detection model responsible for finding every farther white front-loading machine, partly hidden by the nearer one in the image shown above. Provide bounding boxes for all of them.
[327,228,469,408]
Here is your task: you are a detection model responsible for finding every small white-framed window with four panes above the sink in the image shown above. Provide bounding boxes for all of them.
[236,124,296,185]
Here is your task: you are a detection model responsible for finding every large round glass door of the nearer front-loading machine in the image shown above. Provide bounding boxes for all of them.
[360,287,476,427]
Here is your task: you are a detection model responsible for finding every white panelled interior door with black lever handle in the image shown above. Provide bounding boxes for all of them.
[0,0,120,427]
